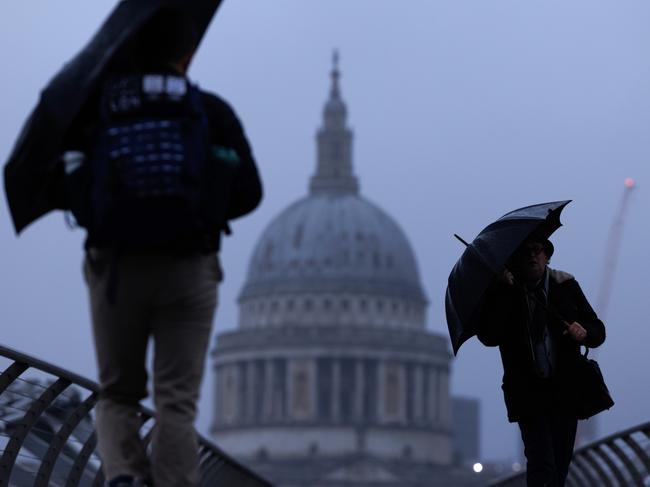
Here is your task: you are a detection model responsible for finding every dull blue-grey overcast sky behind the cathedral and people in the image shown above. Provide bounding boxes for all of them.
[0,0,650,466]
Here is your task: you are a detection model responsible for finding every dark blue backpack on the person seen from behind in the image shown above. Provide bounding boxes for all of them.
[70,74,225,249]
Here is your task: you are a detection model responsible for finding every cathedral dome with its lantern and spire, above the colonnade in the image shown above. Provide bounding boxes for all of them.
[240,51,427,328]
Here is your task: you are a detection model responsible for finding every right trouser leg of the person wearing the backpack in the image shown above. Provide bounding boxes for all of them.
[151,255,221,487]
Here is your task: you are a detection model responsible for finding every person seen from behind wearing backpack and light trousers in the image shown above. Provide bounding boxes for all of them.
[64,10,262,487]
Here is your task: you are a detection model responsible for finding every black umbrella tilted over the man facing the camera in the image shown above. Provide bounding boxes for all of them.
[445,200,571,354]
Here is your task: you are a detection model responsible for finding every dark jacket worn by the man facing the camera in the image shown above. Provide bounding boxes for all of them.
[477,269,605,422]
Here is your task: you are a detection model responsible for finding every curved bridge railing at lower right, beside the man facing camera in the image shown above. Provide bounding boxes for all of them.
[490,422,650,487]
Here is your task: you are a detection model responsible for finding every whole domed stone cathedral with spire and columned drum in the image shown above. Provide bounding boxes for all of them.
[211,54,474,487]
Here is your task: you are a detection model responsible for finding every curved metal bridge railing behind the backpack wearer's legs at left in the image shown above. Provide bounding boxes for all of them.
[0,345,271,487]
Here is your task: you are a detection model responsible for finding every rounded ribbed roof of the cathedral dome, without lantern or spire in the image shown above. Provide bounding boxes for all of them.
[242,193,425,302]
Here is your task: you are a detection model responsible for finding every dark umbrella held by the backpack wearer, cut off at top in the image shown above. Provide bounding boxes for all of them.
[5,0,221,233]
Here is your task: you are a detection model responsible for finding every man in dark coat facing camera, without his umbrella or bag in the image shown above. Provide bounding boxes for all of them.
[470,233,605,487]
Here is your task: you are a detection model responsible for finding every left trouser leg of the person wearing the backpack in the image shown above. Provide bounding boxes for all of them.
[84,255,149,480]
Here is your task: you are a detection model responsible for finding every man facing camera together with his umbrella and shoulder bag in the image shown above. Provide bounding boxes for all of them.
[445,200,613,487]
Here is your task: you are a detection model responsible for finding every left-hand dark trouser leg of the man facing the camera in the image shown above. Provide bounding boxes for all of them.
[519,415,557,487]
